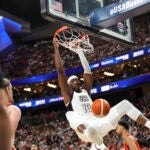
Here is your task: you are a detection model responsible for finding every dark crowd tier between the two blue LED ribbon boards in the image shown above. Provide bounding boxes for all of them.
[13,58,150,102]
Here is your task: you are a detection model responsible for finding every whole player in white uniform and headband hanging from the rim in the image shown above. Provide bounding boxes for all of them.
[53,39,150,150]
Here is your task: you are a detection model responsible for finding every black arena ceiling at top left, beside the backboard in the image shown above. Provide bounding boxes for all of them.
[0,0,49,29]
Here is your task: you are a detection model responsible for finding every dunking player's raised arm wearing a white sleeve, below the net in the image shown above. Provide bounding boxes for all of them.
[78,50,93,95]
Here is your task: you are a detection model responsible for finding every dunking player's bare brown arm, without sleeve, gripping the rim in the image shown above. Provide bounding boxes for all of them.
[53,39,72,104]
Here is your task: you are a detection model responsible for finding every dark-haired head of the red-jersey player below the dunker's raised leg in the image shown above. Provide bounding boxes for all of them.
[116,121,129,136]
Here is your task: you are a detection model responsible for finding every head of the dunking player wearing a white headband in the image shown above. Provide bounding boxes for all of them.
[67,75,81,92]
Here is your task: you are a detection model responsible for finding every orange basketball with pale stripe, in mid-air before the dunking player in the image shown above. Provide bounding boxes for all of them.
[91,99,110,117]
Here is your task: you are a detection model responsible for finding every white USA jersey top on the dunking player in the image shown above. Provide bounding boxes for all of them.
[71,89,92,117]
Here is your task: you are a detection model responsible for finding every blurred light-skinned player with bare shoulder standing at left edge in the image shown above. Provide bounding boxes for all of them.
[0,73,21,150]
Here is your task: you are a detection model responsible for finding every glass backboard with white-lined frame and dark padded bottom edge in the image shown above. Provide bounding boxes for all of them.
[41,0,134,43]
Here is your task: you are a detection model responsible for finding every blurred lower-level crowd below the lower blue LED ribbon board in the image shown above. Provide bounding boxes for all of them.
[15,99,150,150]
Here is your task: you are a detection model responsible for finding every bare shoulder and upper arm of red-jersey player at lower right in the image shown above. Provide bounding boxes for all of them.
[125,136,138,150]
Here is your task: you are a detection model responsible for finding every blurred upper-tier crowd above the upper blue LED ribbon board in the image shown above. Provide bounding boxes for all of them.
[0,13,150,79]
